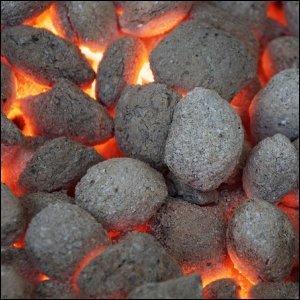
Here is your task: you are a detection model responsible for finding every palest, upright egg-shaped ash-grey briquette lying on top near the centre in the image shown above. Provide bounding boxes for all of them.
[164,88,244,191]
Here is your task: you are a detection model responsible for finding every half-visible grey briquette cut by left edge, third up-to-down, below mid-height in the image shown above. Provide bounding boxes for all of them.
[1,183,25,246]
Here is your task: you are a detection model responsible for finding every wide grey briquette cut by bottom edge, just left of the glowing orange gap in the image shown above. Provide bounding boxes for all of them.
[127,273,202,299]
